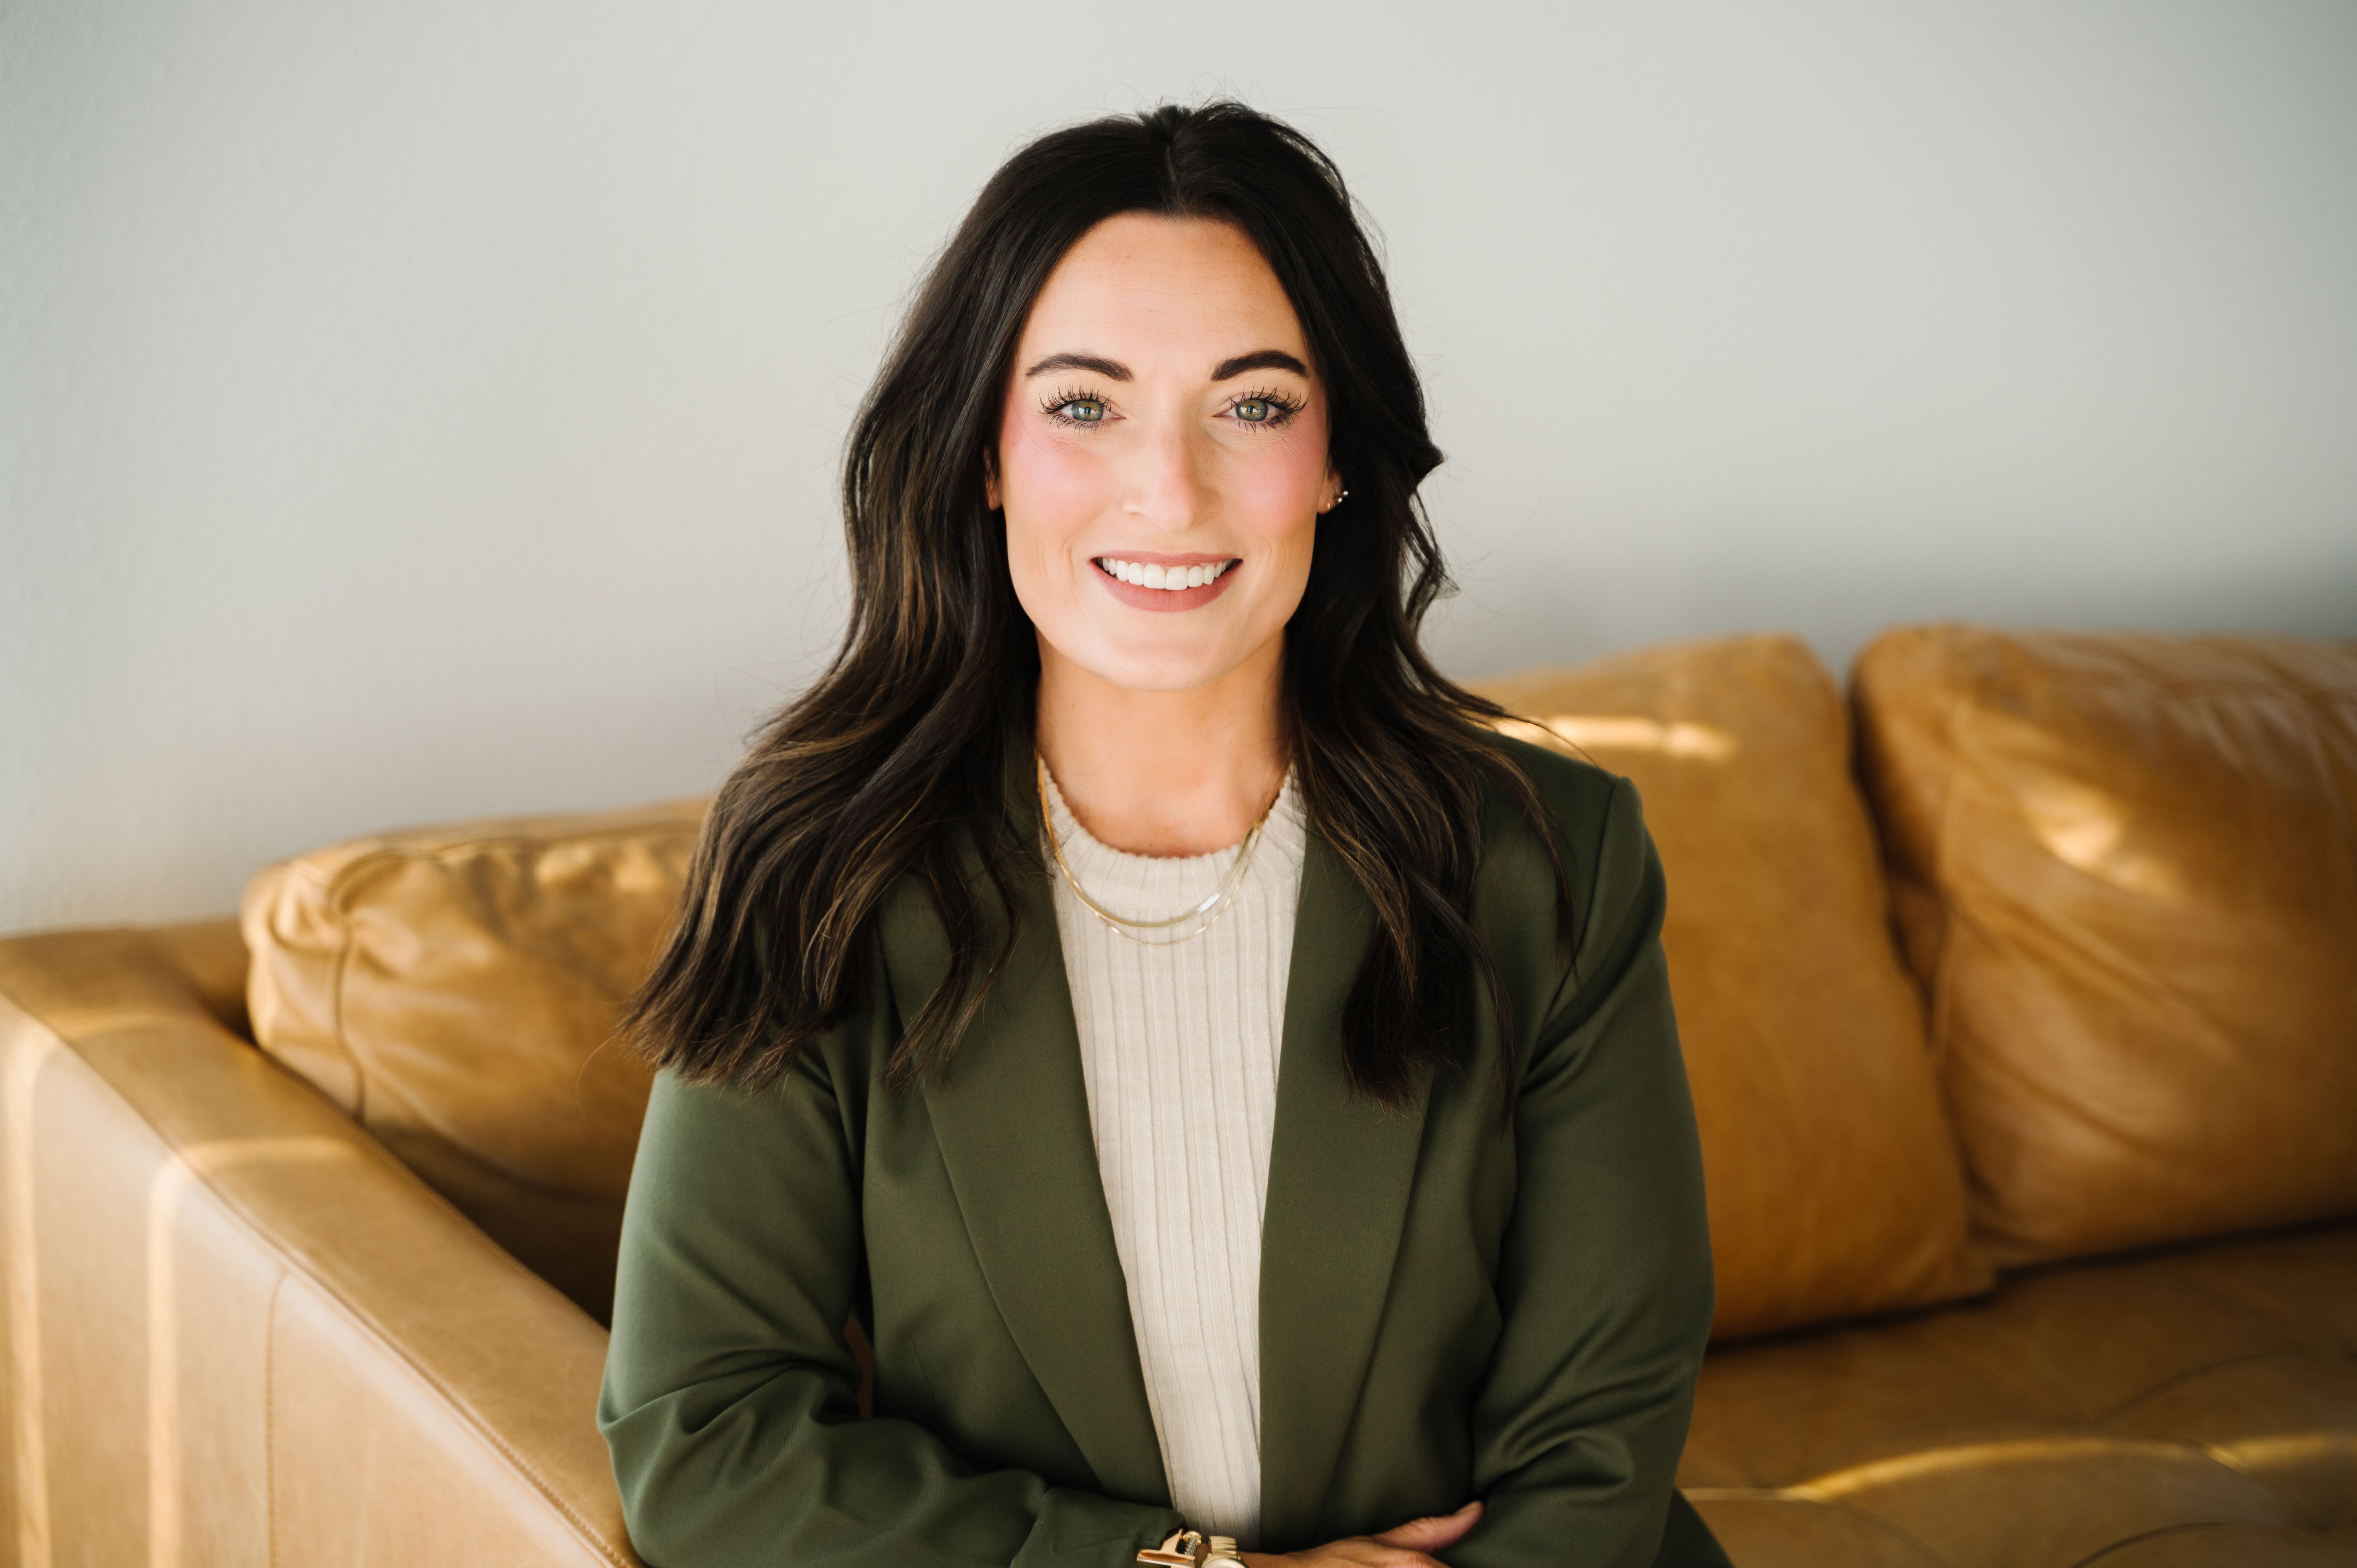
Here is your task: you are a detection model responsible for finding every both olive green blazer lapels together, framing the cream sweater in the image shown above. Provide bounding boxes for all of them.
[879,736,1428,1549]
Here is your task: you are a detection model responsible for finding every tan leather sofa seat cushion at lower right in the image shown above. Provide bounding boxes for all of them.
[1678,1221,2357,1568]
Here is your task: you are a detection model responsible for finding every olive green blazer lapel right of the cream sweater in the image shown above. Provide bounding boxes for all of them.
[1261,832,1431,1549]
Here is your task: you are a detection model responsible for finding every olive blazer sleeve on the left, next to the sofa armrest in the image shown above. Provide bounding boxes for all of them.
[599,1049,1176,1568]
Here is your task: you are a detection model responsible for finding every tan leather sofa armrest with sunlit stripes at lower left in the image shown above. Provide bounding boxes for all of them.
[0,929,636,1568]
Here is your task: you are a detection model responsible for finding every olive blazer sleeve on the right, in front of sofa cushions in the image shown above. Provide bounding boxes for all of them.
[1442,778,1725,1568]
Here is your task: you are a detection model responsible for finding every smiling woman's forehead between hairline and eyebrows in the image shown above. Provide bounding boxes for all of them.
[1021,212,1308,368]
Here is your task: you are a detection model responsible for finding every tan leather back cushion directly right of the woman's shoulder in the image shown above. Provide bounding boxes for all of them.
[1478,637,1991,1337]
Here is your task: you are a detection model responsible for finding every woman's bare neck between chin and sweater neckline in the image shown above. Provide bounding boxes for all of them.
[1035,637,1287,856]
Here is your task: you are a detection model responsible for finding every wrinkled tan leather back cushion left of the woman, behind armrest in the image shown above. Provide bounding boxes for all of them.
[243,802,702,1320]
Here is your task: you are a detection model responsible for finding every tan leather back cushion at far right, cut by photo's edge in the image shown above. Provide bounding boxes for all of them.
[1855,627,2357,1264]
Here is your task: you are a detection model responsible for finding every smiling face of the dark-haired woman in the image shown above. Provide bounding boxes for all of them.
[990,215,1341,691]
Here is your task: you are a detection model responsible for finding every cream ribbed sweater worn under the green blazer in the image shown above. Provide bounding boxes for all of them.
[1047,759,1308,1547]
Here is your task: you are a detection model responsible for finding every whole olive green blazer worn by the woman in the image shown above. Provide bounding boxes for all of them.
[599,740,1725,1568]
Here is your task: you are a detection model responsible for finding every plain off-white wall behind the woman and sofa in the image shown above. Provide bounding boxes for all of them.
[0,0,2357,929]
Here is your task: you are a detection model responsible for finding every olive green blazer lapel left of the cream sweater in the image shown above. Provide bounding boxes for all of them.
[879,745,1169,1507]
